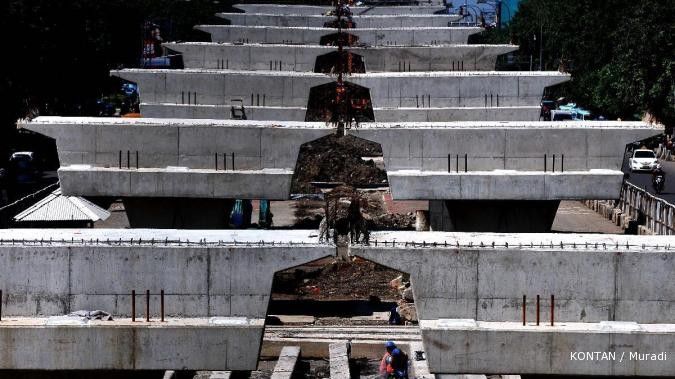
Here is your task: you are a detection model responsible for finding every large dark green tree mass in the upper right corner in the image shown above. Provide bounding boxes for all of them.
[508,0,675,127]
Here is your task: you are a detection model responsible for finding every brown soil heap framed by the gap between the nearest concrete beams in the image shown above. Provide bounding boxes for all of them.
[273,259,401,301]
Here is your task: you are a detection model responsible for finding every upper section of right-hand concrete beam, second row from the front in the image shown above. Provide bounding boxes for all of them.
[349,121,661,172]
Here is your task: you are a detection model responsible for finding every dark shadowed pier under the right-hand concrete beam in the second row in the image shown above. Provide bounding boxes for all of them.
[429,200,560,233]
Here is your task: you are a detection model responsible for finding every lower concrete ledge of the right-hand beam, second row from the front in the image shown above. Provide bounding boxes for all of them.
[387,171,624,200]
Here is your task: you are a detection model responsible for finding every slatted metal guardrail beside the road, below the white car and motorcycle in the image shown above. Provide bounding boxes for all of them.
[615,182,675,235]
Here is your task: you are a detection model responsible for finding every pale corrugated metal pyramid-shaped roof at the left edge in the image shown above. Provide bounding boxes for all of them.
[14,188,110,222]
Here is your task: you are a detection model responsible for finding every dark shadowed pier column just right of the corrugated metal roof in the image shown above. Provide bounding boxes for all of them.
[123,197,234,229]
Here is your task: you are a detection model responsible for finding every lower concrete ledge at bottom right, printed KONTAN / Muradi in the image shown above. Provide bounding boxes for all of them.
[420,319,675,376]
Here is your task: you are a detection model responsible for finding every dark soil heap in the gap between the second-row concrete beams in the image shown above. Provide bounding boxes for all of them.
[291,134,387,193]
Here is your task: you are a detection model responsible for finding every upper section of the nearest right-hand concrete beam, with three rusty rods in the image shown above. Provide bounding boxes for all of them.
[351,232,675,326]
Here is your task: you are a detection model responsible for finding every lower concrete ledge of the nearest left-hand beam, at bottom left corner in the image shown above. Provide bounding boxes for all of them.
[0,317,265,370]
